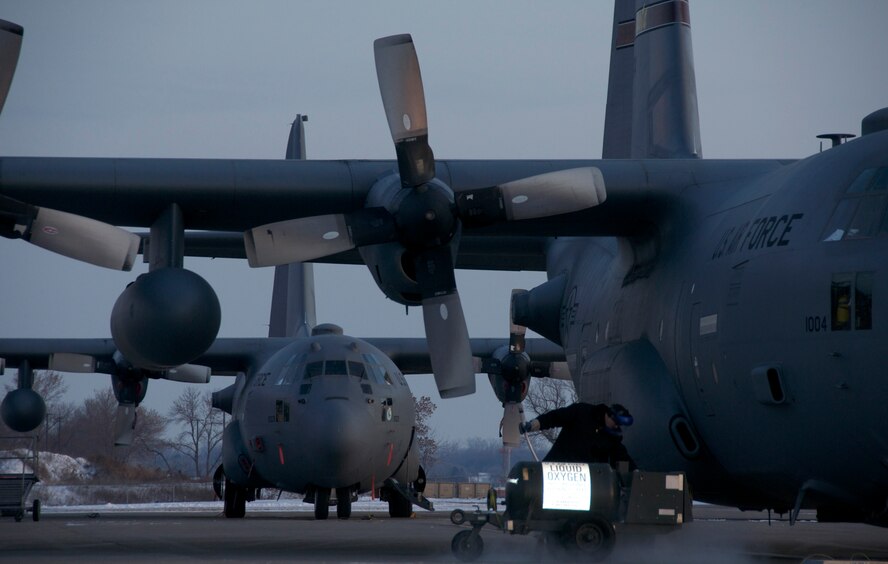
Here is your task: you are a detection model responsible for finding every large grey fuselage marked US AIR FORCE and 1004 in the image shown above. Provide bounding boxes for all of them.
[548,132,888,513]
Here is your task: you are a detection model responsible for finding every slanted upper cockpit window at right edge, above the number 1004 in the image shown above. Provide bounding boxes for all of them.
[823,167,888,241]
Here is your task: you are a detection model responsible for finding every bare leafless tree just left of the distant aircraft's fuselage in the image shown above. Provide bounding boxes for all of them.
[170,387,223,477]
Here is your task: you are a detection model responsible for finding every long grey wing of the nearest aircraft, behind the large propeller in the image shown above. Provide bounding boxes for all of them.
[0,157,784,237]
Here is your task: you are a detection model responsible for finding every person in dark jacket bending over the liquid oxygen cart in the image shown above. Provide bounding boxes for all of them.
[520,402,636,470]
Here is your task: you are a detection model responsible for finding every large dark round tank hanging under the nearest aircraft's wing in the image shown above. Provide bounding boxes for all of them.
[111,268,222,370]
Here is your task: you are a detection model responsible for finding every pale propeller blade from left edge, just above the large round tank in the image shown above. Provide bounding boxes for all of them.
[0,196,141,270]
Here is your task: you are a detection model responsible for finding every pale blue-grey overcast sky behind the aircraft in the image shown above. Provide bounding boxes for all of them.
[0,0,888,439]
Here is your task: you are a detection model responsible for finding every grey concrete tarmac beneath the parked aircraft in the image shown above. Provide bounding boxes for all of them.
[0,507,888,564]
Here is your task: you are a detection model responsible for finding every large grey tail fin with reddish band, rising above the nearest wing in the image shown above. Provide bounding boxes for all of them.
[603,0,703,159]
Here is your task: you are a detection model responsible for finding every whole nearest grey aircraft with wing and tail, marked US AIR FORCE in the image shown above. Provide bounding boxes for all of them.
[0,0,888,525]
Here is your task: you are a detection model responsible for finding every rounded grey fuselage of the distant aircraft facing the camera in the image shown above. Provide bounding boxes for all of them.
[223,328,417,500]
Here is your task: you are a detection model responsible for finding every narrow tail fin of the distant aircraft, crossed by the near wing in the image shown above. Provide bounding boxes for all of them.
[268,114,317,337]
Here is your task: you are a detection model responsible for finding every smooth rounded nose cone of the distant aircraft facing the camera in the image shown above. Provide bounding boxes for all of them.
[302,396,373,487]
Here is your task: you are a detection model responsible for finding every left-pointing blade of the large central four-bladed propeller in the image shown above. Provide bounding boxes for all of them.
[244,207,398,267]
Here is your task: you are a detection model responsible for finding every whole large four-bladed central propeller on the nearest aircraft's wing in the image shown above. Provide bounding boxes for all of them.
[244,34,605,398]
